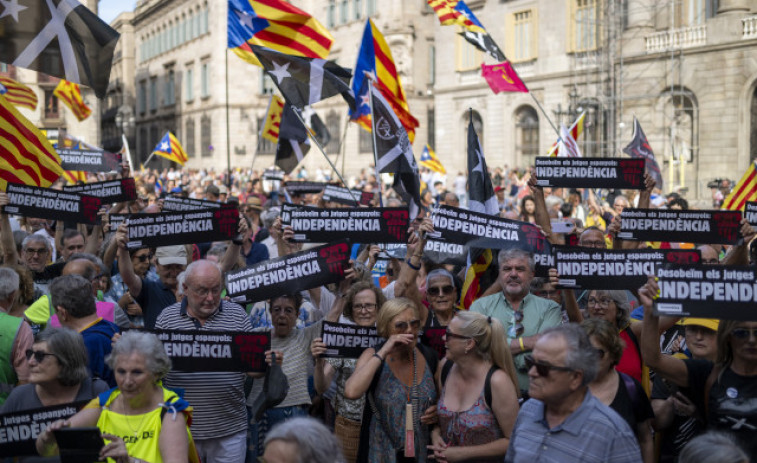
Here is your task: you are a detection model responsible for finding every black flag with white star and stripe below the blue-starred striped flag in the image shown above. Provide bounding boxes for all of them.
[252,45,355,110]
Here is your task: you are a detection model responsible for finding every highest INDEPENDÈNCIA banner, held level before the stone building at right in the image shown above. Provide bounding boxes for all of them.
[534,156,645,190]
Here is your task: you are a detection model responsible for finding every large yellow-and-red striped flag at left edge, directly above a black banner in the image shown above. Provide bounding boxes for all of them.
[0,98,63,191]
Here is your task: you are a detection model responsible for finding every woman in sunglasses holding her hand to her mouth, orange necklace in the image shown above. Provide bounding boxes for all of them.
[344,297,438,463]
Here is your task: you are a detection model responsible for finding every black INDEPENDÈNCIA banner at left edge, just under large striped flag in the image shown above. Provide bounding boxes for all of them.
[3,183,102,225]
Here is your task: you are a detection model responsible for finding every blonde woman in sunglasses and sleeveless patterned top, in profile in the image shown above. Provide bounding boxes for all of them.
[429,311,519,461]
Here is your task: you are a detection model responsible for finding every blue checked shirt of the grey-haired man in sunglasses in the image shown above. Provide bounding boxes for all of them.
[505,390,641,463]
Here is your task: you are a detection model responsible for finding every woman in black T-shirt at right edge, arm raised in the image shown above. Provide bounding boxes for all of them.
[639,277,757,461]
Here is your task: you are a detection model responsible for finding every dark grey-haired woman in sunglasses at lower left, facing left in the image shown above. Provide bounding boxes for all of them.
[0,328,108,463]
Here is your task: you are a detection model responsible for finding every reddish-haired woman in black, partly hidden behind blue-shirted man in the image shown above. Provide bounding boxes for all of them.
[581,318,655,463]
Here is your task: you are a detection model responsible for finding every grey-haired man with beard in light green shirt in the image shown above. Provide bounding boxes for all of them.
[470,249,562,393]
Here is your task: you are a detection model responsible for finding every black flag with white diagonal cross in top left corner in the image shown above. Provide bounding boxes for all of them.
[0,0,119,98]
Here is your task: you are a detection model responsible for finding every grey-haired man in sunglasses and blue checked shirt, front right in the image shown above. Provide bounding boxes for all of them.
[505,324,642,463]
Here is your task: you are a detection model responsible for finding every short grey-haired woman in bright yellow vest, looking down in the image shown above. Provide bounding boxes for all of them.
[37,331,199,463]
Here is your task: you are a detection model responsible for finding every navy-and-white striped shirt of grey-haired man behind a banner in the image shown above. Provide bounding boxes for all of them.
[155,298,252,440]
